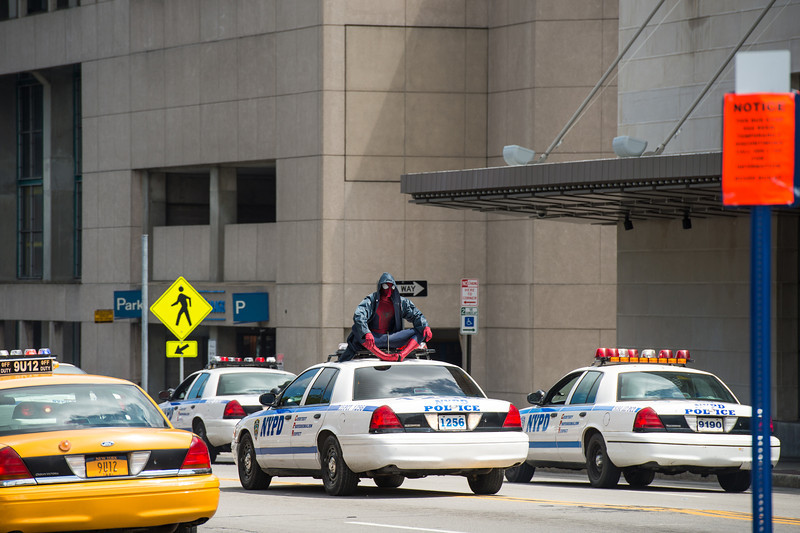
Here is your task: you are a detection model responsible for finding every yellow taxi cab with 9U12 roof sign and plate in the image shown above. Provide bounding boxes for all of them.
[0,349,219,533]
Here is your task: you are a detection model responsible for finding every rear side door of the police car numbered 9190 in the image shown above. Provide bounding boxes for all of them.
[556,370,603,463]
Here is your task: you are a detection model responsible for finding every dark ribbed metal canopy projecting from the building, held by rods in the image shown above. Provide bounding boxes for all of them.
[400,152,772,224]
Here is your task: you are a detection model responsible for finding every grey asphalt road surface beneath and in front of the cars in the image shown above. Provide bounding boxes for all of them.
[198,454,800,533]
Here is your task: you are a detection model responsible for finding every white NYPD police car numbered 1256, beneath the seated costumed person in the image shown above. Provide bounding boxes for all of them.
[232,348,528,496]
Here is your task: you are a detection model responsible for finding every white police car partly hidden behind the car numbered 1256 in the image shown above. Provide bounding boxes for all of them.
[158,357,295,462]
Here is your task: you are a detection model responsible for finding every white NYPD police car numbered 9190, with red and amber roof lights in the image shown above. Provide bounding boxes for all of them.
[506,348,780,492]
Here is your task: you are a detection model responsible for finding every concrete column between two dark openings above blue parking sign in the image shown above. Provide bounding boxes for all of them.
[208,167,236,281]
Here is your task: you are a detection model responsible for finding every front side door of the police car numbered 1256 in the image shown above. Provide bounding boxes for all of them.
[253,368,319,468]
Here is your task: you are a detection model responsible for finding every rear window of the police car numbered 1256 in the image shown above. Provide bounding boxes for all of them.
[353,363,484,400]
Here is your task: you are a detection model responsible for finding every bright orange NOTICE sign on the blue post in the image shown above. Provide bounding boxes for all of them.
[722,93,795,206]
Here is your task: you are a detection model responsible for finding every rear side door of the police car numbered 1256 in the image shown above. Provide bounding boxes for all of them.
[291,367,339,470]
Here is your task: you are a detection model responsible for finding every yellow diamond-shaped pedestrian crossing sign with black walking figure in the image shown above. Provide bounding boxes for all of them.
[150,276,213,340]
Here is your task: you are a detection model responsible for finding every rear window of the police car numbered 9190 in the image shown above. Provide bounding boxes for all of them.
[617,371,738,403]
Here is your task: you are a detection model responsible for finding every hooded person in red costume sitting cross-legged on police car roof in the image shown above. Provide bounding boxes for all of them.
[339,272,433,361]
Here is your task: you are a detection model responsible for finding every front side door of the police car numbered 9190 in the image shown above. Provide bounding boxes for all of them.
[522,372,583,462]
